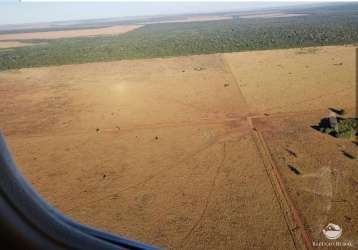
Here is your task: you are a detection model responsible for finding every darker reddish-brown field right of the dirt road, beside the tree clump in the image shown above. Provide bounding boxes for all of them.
[254,111,358,245]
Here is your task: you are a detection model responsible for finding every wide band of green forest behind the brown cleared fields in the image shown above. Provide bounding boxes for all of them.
[0,4,358,70]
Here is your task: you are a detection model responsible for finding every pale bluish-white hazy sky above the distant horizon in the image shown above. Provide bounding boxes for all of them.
[0,2,324,27]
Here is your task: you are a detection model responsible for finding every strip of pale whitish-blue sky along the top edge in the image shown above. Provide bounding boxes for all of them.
[0,0,314,25]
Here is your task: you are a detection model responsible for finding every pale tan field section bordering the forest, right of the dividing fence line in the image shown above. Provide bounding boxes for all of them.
[224,46,356,114]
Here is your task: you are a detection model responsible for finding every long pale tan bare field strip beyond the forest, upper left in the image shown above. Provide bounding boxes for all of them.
[0,25,142,41]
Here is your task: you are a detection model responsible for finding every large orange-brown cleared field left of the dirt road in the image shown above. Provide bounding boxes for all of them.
[0,55,294,249]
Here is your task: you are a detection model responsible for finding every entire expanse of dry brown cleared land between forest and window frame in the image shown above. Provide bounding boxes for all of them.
[0,46,357,249]
